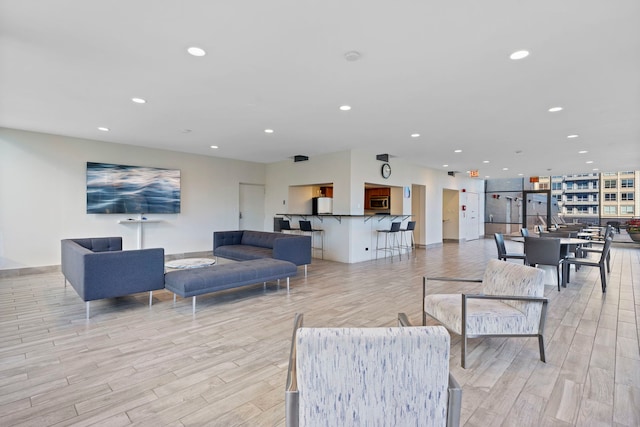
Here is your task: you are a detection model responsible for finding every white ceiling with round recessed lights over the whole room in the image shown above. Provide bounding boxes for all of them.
[0,0,640,178]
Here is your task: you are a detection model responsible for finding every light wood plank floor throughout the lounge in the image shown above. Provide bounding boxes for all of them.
[0,239,640,426]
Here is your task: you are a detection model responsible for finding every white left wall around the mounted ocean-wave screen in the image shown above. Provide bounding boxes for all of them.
[0,128,264,269]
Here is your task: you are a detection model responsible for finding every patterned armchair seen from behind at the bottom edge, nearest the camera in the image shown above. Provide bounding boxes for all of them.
[285,314,462,427]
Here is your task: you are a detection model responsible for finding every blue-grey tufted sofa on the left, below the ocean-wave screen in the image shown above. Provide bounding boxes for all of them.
[61,237,164,319]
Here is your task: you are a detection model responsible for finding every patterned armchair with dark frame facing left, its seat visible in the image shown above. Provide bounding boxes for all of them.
[422,259,548,368]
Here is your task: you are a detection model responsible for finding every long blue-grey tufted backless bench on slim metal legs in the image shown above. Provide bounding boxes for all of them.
[164,258,298,313]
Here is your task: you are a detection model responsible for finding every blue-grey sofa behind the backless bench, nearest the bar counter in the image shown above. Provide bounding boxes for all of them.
[213,230,311,273]
